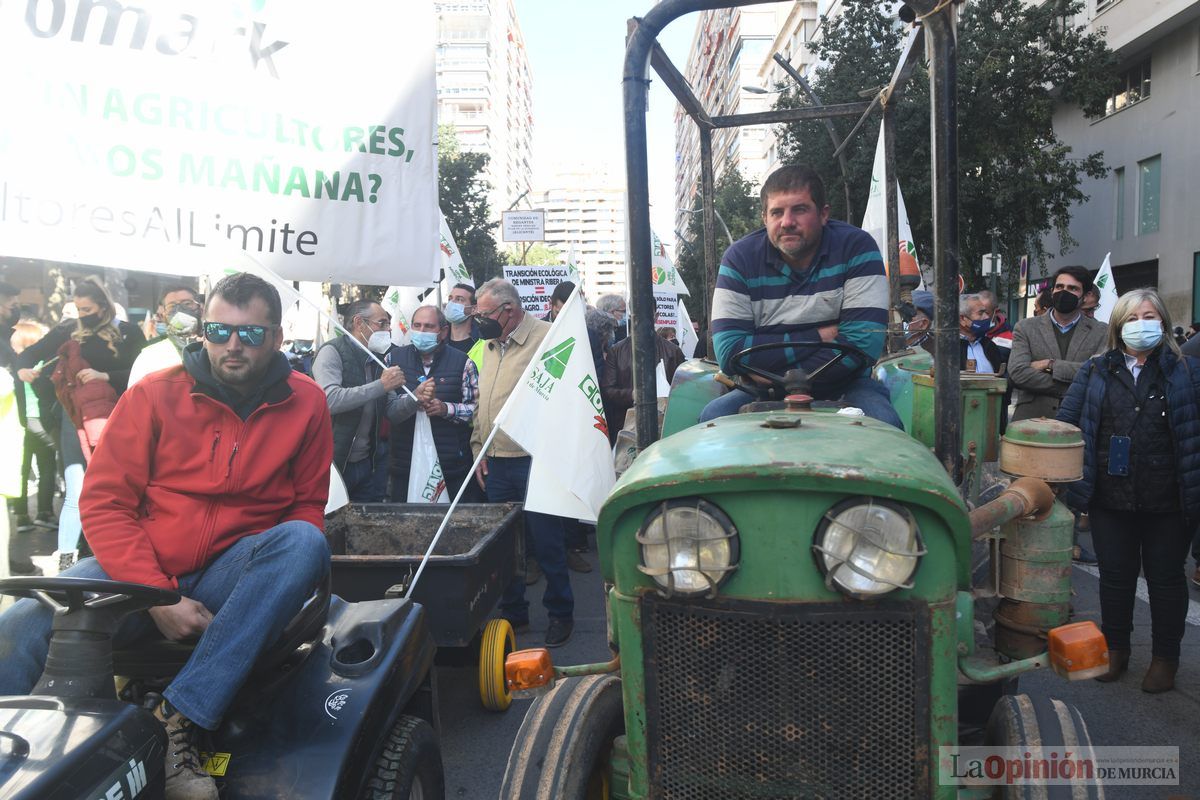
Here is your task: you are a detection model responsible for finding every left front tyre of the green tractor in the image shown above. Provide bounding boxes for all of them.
[500,675,625,800]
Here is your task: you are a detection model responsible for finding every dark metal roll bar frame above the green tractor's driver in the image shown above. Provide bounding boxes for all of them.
[622,0,962,482]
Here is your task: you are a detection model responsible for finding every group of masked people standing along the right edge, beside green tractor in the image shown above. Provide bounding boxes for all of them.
[905,267,1200,693]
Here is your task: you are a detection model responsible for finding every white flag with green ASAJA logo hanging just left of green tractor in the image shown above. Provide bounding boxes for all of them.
[496,287,616,522]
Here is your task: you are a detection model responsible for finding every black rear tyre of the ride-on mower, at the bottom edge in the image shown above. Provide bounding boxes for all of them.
[362,716,445,800]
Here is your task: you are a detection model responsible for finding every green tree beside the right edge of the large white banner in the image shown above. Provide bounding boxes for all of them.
[438,125,504,284]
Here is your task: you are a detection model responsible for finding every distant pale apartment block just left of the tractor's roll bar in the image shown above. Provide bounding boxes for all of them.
[530,167,628,300]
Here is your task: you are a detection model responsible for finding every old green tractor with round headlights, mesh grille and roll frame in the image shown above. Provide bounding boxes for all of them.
[500,0,1106,800]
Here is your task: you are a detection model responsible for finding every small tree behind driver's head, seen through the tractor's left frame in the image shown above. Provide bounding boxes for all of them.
[676,167,762,320]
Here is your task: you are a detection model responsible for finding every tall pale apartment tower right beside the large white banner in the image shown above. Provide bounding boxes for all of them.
[434,0,533,217]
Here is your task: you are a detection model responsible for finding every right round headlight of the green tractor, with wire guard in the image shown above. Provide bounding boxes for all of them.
[812,498,925,597]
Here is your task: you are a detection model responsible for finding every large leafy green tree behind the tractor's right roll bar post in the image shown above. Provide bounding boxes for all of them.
[778,0,1116,293]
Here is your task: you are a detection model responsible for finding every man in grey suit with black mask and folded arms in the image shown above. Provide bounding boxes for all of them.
[1008,266,1109,422]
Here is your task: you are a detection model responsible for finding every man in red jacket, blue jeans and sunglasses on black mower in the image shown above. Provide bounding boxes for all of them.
[0,273,332,800]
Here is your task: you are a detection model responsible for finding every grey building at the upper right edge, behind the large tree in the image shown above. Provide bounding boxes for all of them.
[1044,0,1200,326]
